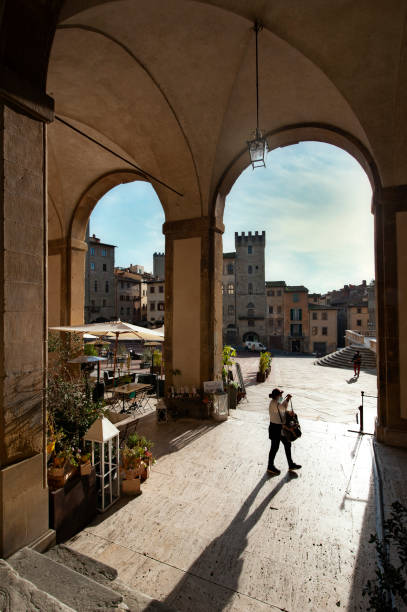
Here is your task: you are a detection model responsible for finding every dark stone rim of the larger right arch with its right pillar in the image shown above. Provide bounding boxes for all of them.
[213,124,407,445]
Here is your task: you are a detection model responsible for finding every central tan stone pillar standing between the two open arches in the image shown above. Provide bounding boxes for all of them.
[163,217,224,388]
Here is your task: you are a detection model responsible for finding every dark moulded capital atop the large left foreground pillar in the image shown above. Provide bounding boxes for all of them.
[0,66,54,123]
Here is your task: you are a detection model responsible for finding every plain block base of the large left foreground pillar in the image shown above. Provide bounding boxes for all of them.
[0,455,49,558]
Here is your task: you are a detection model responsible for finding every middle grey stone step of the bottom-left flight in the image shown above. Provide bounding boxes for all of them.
[7,548,128,612]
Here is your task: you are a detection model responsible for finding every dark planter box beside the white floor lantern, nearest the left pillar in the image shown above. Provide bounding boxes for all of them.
[49,468,97,542]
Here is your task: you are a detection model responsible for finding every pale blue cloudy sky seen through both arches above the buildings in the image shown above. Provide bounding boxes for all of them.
[90,142,374,292]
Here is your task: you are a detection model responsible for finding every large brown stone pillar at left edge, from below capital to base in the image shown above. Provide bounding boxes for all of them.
[0,102,54,557]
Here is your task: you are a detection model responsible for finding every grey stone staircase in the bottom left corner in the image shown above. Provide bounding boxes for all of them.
[0,544,174,612]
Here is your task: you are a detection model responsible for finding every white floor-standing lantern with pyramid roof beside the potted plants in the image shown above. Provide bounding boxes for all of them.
[83,417,120,512]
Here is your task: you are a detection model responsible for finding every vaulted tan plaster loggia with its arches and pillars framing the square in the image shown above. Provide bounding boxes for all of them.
[0,0,407,555]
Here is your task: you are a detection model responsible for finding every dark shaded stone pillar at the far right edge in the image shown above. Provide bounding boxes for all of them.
[373,186,407,447]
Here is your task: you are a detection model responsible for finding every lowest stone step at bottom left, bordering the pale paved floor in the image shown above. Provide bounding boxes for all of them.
[45,544,174,612]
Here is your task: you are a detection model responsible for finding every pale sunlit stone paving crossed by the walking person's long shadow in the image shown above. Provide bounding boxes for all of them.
[68,356,384,612]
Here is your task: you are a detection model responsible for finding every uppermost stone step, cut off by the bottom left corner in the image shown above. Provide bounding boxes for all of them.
[0,559,75,612]
